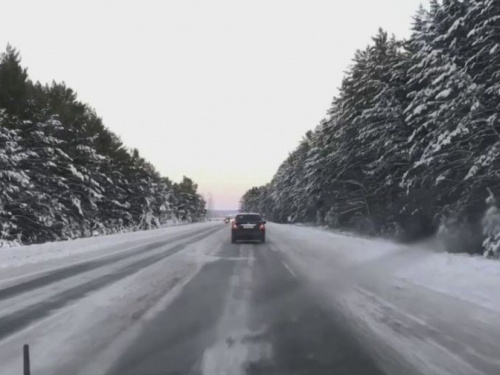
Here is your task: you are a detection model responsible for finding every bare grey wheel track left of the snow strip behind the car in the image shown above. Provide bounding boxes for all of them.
[106,241,242,375]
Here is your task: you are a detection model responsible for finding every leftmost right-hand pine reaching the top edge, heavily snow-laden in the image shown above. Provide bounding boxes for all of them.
[401,1,476,236]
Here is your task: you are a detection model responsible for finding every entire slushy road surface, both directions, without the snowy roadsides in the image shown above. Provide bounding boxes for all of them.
[0,224,382,375]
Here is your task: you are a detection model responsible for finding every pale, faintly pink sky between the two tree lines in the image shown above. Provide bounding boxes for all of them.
[0,0,427,209]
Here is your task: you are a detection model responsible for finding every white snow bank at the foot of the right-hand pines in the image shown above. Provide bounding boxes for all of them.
[273,225,500,313]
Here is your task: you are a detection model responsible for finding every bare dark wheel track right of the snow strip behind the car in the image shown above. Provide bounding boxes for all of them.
[245,237,383,375]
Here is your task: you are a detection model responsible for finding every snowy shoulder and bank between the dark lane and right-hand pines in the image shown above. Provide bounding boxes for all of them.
[270,225,500,375]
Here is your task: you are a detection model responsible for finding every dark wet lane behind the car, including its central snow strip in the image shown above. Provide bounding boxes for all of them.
[110,236,381,375]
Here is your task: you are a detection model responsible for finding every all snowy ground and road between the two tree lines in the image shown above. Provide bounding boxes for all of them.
[0,223,500,375]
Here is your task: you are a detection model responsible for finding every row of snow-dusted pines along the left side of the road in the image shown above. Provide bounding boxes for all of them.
[0,46,205,243]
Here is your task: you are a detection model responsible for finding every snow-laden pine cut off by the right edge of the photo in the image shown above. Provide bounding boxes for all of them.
[464,0,500,204]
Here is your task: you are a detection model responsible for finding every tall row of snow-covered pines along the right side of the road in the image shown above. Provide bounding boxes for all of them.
[241,0,500,254]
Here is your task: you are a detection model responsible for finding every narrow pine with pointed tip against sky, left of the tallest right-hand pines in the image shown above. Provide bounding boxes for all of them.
[353,30,408,233]
